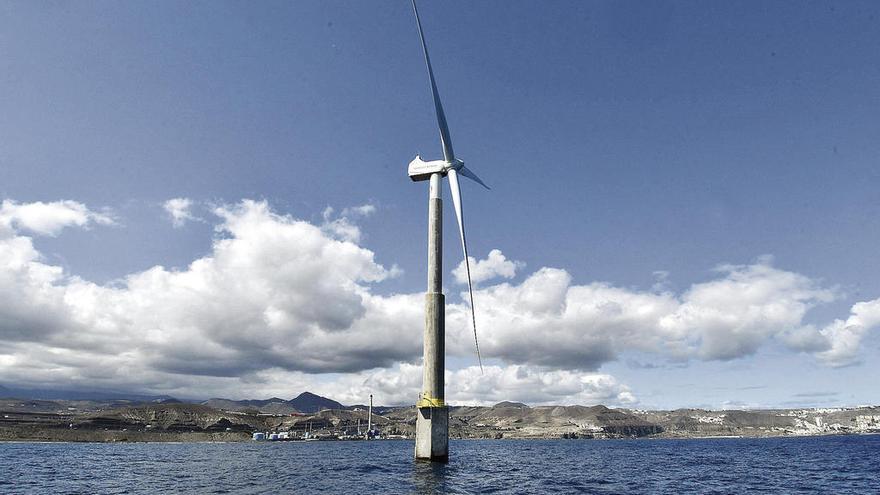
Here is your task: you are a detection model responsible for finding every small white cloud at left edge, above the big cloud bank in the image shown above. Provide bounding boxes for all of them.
[0,199,114,236]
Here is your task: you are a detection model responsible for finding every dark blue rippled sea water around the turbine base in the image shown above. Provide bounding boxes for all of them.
[0,436,880,494]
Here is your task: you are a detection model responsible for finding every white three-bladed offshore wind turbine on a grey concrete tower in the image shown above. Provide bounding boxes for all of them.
[408,0,489,461]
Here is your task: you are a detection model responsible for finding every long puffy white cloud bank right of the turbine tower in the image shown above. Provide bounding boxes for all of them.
[447,260,844,370]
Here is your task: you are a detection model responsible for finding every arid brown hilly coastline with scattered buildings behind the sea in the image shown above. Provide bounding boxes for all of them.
[0,394,880,443]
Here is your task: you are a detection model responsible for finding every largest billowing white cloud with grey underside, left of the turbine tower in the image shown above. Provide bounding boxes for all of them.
[0,201,414,386]
